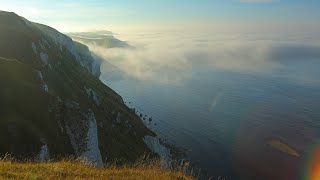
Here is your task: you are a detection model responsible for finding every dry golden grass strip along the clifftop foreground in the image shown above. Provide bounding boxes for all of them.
[0,160,192,180]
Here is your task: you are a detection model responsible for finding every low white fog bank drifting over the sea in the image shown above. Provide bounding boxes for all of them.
[74,32,320,83]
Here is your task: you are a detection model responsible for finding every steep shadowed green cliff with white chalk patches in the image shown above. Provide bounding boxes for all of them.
[0,11,154,166]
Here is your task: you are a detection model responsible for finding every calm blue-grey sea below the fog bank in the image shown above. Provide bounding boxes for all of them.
[97,32,320,179]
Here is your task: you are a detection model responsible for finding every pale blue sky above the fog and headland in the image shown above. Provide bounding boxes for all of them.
[0,0,320,32]
